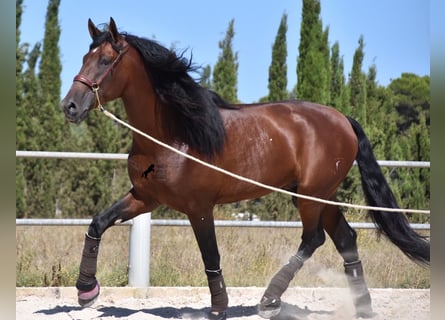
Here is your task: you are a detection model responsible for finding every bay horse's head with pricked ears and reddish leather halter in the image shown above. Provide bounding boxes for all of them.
[61,18,128,123]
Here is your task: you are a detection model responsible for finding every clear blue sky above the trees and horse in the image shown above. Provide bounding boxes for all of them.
[20,0,430,103]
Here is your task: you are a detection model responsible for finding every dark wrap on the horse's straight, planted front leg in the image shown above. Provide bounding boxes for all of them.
[206,270,229,319]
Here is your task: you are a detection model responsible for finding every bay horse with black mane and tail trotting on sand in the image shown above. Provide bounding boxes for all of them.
[62,19,430,319]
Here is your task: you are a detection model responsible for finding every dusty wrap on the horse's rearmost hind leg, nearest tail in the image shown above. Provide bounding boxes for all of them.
[344,260,375,318]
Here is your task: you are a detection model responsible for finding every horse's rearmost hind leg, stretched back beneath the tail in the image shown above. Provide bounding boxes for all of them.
[323,202,375,318]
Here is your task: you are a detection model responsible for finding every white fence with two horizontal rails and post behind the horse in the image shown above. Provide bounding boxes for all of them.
[15,151,430,287]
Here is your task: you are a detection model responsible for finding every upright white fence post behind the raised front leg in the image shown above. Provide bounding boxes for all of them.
[128,212,151,287]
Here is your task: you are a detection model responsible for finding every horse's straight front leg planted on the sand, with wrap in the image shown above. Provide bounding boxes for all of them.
[189,210,229,320]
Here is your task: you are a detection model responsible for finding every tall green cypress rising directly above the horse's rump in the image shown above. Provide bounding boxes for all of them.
[294,0,330,104]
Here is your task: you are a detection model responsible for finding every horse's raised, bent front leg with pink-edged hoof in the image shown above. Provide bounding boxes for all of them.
[76,189,156,307]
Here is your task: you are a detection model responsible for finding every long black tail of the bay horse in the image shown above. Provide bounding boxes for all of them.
[348,117,430,265]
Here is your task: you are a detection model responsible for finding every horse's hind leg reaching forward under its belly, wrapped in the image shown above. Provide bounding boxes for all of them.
[258,199,325,319]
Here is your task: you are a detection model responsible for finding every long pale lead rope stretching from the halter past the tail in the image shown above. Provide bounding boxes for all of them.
[96,106,430,214]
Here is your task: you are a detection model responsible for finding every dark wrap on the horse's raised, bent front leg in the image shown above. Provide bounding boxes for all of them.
[76,234,100,291]
